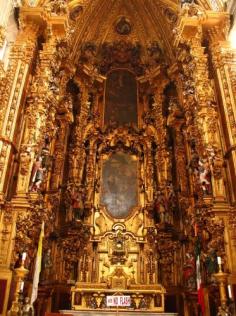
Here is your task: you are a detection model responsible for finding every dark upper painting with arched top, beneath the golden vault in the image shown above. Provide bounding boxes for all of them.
[104,69,138,126]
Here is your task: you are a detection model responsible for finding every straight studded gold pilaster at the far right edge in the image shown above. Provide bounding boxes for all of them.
[208,25,236,201]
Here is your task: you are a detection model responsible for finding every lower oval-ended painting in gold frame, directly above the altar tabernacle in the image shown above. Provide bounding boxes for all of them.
[101,152,138,218]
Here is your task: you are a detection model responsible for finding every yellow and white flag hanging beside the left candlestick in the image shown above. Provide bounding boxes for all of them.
[30,222,44,304]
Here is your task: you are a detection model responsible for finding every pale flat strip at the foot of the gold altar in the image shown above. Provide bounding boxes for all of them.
[60,310,178,316]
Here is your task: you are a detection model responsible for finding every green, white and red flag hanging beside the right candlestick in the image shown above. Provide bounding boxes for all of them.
[195,236,205,316]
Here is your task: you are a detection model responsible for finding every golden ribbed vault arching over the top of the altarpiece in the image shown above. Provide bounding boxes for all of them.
[32,0,224,60]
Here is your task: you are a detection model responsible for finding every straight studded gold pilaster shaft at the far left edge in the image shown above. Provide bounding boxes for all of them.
[0,24,38,199]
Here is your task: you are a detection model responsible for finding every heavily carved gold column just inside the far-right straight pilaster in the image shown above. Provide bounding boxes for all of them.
[191,39,226,201]
